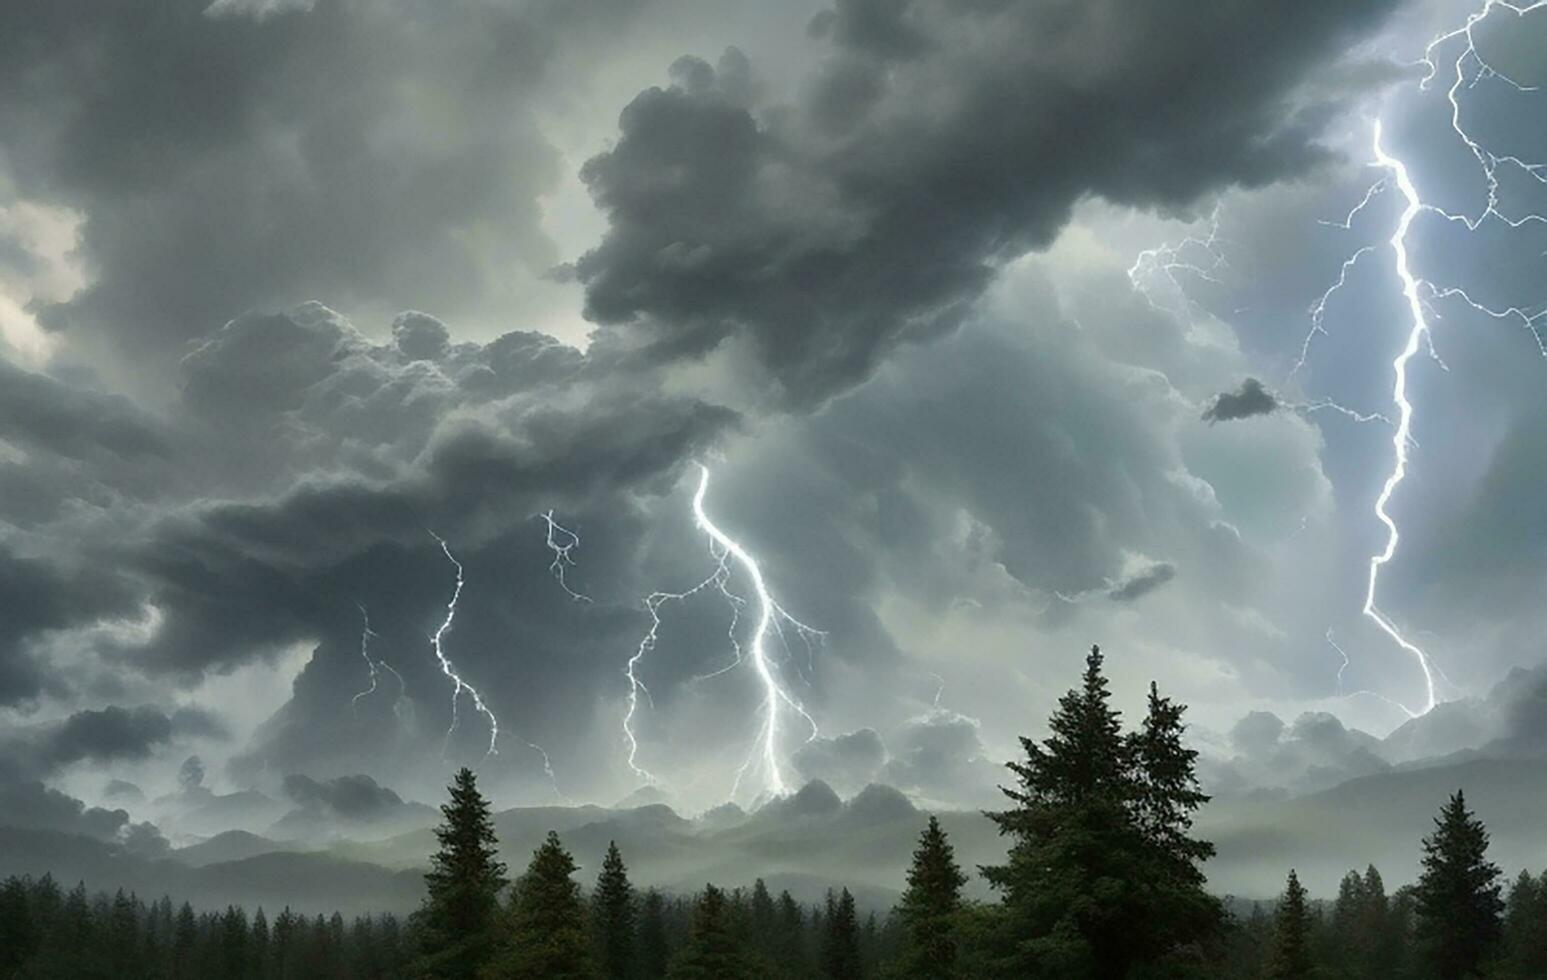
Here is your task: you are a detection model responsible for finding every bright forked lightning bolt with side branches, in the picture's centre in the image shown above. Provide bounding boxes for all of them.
[623,464,823,799]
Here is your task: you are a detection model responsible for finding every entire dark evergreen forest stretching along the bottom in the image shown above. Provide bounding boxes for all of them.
[0,647,1547,980]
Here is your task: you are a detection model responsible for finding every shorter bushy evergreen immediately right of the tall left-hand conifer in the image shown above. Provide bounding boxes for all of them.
[497,830,596,980]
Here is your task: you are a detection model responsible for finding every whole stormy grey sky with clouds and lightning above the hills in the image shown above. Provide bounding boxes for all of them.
[0,0,1547,814]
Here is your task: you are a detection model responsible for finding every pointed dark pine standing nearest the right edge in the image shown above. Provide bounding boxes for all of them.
[1416,790,1504,978]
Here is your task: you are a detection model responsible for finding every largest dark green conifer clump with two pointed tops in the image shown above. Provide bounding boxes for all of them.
[982,647,1222,977]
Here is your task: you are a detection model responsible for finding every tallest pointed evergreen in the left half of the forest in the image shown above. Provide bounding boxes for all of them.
[418,766,506,977]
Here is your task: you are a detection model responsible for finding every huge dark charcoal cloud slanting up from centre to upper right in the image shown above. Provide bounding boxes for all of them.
[575,0,1392,404]
